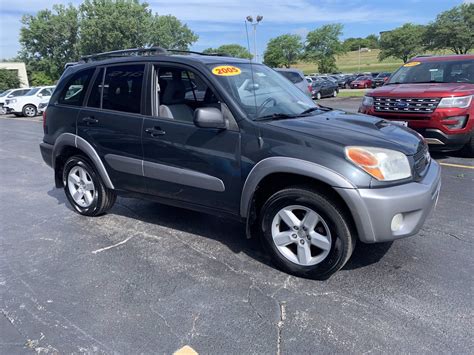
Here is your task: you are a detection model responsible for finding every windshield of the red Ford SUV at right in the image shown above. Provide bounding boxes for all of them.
[388,59,474,84]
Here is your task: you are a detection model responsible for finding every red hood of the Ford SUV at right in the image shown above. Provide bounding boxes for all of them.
[369,83,474,97]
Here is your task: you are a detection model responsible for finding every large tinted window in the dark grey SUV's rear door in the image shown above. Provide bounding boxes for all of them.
[101,64,145,113]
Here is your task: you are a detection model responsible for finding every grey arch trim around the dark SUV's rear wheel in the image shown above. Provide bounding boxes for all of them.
[52,133,114,189]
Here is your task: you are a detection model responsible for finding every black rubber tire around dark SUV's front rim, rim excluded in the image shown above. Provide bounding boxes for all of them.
[260,186,356,280]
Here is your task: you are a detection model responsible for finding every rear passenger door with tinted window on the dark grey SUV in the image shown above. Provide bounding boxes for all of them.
[77,63,146,192]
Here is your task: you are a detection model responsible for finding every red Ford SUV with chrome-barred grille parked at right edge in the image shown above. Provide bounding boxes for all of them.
[359,54,474,157]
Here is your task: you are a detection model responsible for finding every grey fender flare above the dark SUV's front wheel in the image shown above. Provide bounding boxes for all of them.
[240,157,356,218]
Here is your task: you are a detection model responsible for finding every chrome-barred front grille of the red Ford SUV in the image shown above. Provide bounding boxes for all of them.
[374,97,440,113]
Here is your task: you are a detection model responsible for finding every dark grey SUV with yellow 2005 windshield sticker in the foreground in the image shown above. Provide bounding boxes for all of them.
[40,48,440,278]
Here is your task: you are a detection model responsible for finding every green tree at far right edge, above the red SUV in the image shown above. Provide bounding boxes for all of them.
[425,3,474,54]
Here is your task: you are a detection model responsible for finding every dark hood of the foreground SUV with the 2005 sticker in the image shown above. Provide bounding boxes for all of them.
[268,110,422,155]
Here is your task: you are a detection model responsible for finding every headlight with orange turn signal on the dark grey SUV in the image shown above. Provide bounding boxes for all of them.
[346,147,411,181]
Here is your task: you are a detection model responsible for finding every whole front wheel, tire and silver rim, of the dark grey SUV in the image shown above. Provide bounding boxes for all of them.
[261,187,355,279]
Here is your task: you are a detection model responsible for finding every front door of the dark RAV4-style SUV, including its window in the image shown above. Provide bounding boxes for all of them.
[142,66,240,212]
